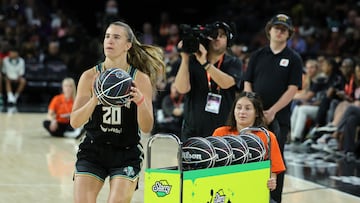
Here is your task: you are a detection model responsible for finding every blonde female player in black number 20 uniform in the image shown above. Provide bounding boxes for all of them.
[71,21,164,203]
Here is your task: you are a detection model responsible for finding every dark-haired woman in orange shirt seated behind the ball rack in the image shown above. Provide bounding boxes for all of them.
[213,92,285,198]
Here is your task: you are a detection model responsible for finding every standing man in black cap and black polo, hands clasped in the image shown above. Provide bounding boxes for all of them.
[244,14,303,203]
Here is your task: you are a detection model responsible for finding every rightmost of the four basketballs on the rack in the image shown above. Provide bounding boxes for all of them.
[239,132,266,162]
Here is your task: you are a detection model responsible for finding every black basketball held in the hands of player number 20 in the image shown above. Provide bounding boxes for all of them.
[94,68,132,106]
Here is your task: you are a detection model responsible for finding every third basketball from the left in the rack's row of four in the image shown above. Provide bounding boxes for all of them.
[223,135,249,165]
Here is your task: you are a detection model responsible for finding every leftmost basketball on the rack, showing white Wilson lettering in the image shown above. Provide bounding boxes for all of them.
[182,137,216,171]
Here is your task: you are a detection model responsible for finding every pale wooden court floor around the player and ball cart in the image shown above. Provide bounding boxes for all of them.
[0,109,360,203]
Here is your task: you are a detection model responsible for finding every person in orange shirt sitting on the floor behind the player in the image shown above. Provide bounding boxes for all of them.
[43,78,83,138]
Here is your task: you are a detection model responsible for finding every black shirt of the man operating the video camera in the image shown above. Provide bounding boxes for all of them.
[182,54,243,138]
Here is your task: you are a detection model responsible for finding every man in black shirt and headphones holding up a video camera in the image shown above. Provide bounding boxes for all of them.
[175,22,242,141]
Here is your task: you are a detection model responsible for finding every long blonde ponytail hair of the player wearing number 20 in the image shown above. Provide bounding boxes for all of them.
[110,21,165,89]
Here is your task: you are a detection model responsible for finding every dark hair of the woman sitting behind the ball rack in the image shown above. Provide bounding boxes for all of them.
[227,91,266,131]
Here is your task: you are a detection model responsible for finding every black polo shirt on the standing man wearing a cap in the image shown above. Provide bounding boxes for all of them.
[244,46,303,125]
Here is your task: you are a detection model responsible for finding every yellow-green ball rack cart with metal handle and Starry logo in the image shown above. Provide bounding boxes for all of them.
[144,128,271,203]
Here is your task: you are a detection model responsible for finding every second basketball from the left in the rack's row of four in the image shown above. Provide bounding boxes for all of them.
[206,136,233,167]
